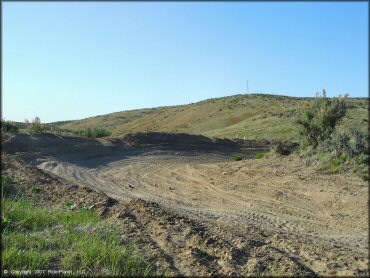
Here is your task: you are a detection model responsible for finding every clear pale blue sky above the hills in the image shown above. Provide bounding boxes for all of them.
[2,2,369,122]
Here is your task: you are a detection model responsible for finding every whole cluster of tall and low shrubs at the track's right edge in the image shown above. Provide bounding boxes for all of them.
[296,90,369,180]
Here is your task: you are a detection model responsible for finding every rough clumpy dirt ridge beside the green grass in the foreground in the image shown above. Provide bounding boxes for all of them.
[116,200,313,276]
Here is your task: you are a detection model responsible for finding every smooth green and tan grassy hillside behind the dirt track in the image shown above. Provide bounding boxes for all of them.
[58,94,368,141]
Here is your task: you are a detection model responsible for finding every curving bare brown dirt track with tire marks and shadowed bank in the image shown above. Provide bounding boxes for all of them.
[5,135,369,276]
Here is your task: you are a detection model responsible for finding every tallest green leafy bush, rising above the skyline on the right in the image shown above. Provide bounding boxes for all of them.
[296,90,347,148]
